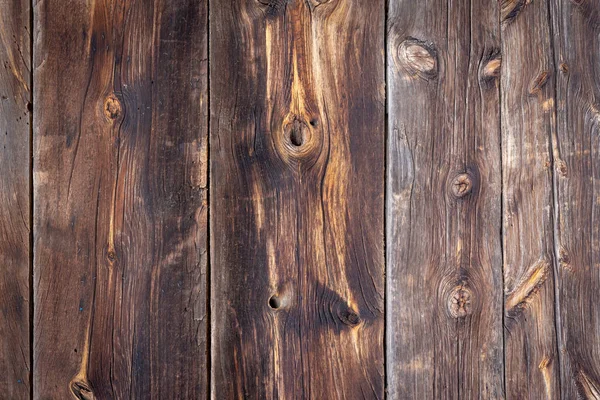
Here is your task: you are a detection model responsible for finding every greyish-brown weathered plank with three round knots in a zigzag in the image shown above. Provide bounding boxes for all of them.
[386,0,503,399]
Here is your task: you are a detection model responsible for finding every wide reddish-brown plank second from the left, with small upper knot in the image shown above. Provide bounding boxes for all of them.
[34,0,208,399]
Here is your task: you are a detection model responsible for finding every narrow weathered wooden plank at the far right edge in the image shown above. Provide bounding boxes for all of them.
[547,0,600,399]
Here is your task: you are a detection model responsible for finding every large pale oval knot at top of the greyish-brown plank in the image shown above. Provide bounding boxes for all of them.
[398,38,438,80]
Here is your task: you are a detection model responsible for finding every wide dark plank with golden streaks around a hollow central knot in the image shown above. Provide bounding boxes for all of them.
[210,0,385,399]
